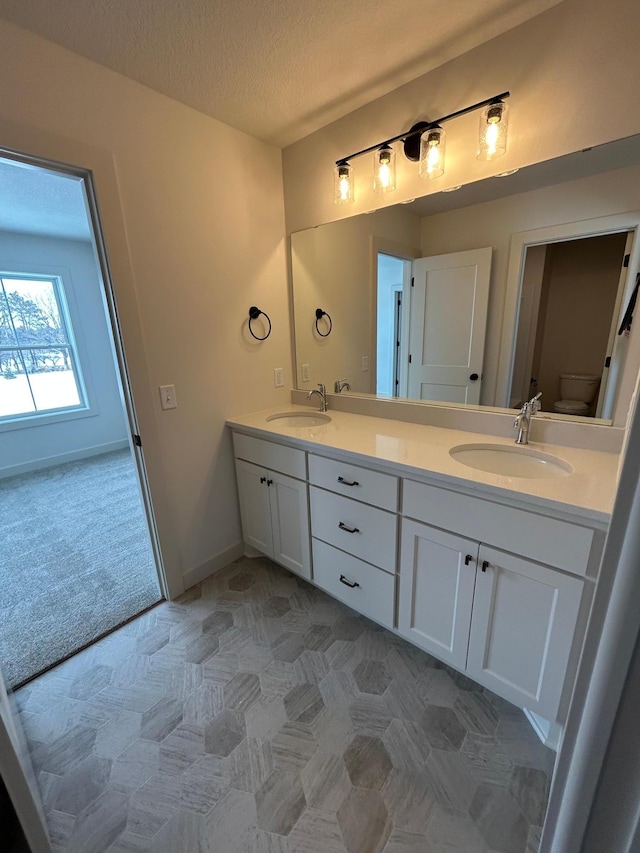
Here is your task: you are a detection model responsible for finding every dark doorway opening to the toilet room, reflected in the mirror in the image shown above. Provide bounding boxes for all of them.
[509,231,634,418]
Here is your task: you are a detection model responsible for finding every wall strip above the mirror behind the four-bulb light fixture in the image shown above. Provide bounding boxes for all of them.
[283,0,640,231]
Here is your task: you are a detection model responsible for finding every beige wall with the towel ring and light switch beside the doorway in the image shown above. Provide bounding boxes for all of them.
[0,21,292,592]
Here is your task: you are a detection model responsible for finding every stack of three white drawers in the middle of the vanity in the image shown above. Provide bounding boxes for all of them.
[309,454,398,628]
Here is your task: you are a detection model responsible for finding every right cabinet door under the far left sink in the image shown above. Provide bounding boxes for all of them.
[268,471,311,579]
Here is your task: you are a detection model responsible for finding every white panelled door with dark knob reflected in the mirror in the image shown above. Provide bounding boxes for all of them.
[408,246,492,404]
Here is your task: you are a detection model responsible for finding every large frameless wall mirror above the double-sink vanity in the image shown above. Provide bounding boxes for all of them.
[291,137,640,422]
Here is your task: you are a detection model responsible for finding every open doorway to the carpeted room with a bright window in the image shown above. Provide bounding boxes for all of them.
[0,155,164,687]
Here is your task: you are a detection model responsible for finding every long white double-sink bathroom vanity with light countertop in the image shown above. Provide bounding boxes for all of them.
[228,406,618,745]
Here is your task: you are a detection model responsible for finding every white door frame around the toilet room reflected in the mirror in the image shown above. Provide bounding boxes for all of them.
[495,210,640,426]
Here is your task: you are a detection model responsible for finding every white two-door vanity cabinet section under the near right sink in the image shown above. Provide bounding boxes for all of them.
[398,481,593,720]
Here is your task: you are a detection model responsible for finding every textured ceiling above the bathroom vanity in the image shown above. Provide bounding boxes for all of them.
[0,0,561,146]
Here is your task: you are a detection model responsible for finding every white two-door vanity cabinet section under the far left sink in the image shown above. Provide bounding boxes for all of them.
[233,433,311,579]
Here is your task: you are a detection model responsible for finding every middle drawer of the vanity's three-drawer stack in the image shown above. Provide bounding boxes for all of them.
[309,486,398,572]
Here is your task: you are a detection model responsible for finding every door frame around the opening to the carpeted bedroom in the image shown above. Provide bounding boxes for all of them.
[0,118,184,599]
